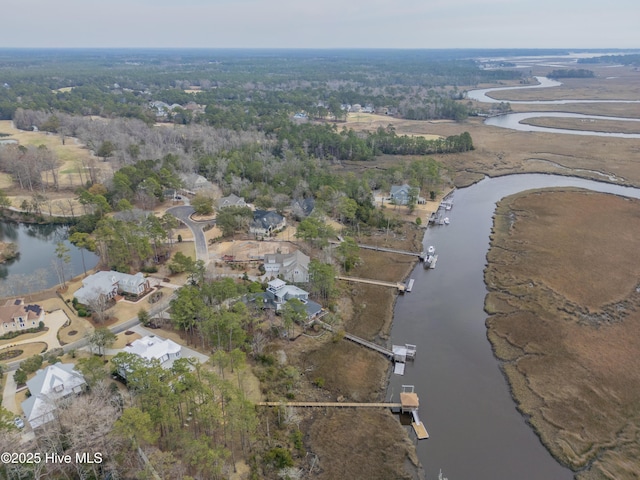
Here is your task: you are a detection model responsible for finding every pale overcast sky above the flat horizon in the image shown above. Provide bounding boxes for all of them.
[0,0,640,49]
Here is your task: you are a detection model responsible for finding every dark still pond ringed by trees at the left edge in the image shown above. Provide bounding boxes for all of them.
[0,222,98,297]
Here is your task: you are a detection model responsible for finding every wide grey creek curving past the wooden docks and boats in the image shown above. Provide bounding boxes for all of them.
[387,174,640,480]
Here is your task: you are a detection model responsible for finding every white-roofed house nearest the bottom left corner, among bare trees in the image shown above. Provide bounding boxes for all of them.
[21,363,87,429]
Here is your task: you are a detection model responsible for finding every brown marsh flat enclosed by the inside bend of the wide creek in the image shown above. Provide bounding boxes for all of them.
[485,191,640,479]
